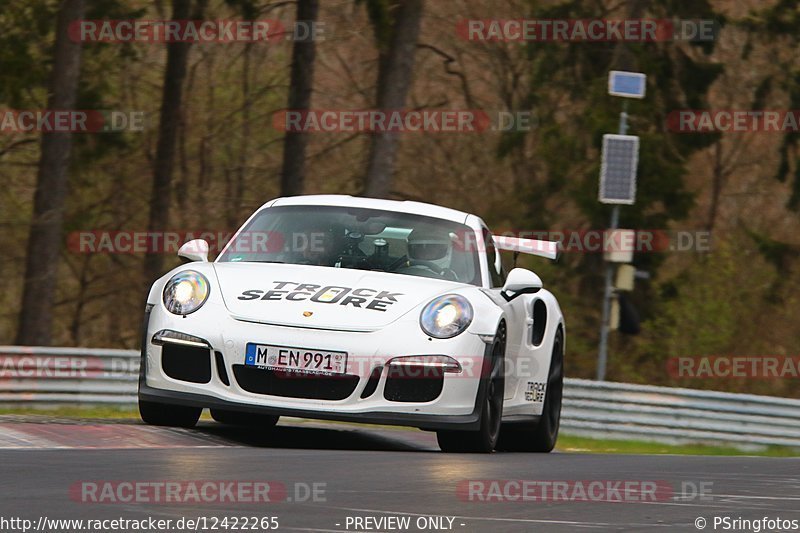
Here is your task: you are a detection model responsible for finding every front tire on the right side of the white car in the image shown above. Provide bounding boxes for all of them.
[436,323,506,453]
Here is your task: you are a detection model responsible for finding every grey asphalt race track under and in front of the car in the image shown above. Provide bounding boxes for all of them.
[0,417,800,533]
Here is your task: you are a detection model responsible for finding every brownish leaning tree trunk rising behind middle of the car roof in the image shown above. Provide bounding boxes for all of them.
[366,0,423,198]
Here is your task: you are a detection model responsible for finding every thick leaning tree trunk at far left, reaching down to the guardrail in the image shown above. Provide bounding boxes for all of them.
[16,0,84,346]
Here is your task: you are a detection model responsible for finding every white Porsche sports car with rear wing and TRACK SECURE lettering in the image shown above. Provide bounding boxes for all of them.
[139,196,565,452]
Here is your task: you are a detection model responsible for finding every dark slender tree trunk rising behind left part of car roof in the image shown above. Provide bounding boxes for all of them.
[281,0,319,196]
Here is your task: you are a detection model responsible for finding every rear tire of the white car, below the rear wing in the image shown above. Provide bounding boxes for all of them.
[497,328,564,453]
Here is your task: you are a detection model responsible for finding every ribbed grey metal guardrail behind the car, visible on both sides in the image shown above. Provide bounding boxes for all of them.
[0,346,800,448]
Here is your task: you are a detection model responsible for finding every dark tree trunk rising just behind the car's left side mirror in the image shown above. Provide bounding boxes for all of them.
[144,0,191,283]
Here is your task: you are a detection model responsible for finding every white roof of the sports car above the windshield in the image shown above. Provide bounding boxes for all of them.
[263,194,469,224]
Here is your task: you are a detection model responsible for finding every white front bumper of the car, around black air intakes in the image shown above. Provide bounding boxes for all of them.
[139,304,490,430]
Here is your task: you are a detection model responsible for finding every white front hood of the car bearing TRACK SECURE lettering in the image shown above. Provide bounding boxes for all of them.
[214,263,471,331]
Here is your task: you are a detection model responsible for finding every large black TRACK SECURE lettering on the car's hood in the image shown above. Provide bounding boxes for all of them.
[238,281,403,312]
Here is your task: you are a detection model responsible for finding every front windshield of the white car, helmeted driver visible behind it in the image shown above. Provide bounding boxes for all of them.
[217,206,481,285]
